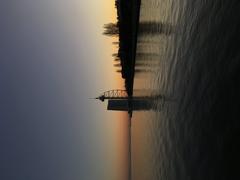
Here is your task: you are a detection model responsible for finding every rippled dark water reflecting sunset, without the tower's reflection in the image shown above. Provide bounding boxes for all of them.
[132,0,240,180]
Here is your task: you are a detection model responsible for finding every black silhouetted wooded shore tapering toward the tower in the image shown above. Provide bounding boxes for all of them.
[103,0,141,97]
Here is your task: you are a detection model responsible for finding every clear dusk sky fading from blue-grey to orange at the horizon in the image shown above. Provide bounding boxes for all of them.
[0,0,128,180]
